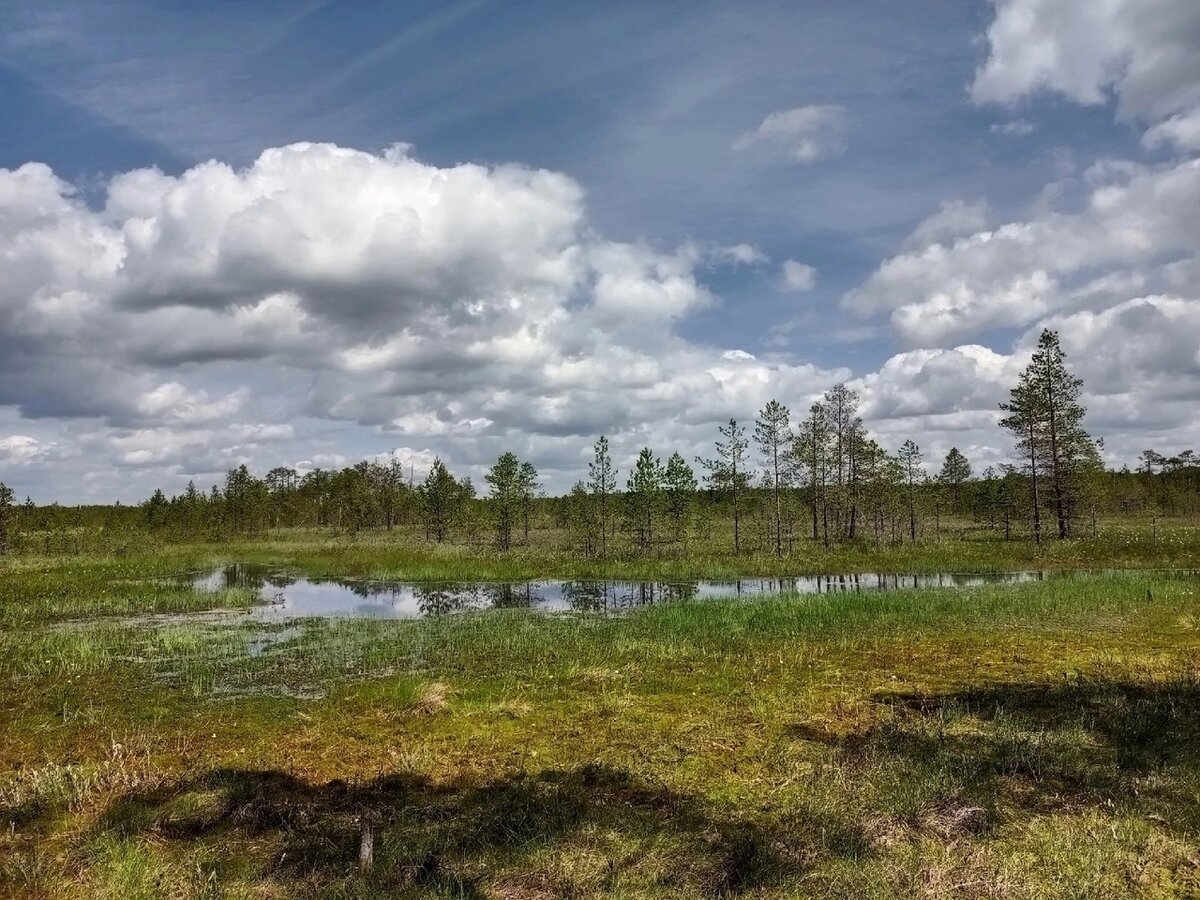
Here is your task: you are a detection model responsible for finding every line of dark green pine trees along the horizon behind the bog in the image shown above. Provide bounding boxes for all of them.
[0,330,1200,557]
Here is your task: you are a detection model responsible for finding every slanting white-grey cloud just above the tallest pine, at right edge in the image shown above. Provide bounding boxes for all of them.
[844,160,1200,347]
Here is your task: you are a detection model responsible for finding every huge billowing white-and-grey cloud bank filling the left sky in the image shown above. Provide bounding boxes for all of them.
[0,144,848,504]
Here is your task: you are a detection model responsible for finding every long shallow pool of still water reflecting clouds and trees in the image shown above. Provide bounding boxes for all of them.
[179,564,1044,619]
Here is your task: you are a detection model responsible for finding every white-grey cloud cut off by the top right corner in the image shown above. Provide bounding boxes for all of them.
[971,0,1200,150]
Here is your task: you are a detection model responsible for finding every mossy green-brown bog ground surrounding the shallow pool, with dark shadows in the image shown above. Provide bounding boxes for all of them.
[0,530,1200,898]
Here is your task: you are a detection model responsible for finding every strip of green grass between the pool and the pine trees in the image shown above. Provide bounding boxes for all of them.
[9,520,1200,609]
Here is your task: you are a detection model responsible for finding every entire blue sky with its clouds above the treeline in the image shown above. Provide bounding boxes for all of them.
[0,0,1200,503]
